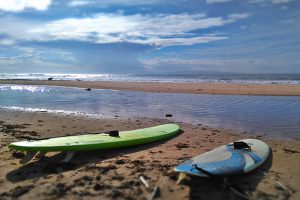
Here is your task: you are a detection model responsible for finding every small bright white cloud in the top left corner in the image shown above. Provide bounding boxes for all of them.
[0,0,51,12]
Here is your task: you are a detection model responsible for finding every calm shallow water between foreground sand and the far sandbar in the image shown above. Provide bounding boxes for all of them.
[0,85,300,139]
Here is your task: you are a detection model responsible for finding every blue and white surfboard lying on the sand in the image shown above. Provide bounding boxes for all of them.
[174,139,270,177]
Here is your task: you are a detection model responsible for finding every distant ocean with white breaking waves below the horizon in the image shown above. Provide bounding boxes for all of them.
[0,72,300,84]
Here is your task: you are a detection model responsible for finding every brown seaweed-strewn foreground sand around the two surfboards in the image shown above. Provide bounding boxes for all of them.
[0,110,300,200]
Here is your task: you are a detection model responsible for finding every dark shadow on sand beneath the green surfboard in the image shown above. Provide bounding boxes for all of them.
[6,130,184,182]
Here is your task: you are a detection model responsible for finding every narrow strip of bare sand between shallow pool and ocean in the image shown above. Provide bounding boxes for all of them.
[0,79,300,96]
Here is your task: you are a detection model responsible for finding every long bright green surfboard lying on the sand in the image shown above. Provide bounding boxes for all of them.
[9,124,180,152]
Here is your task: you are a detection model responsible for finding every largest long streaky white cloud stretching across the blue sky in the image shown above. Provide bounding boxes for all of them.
[5,13,248,46]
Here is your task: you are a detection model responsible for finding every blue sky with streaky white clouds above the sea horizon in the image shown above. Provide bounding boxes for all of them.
[0,0,300,74]
